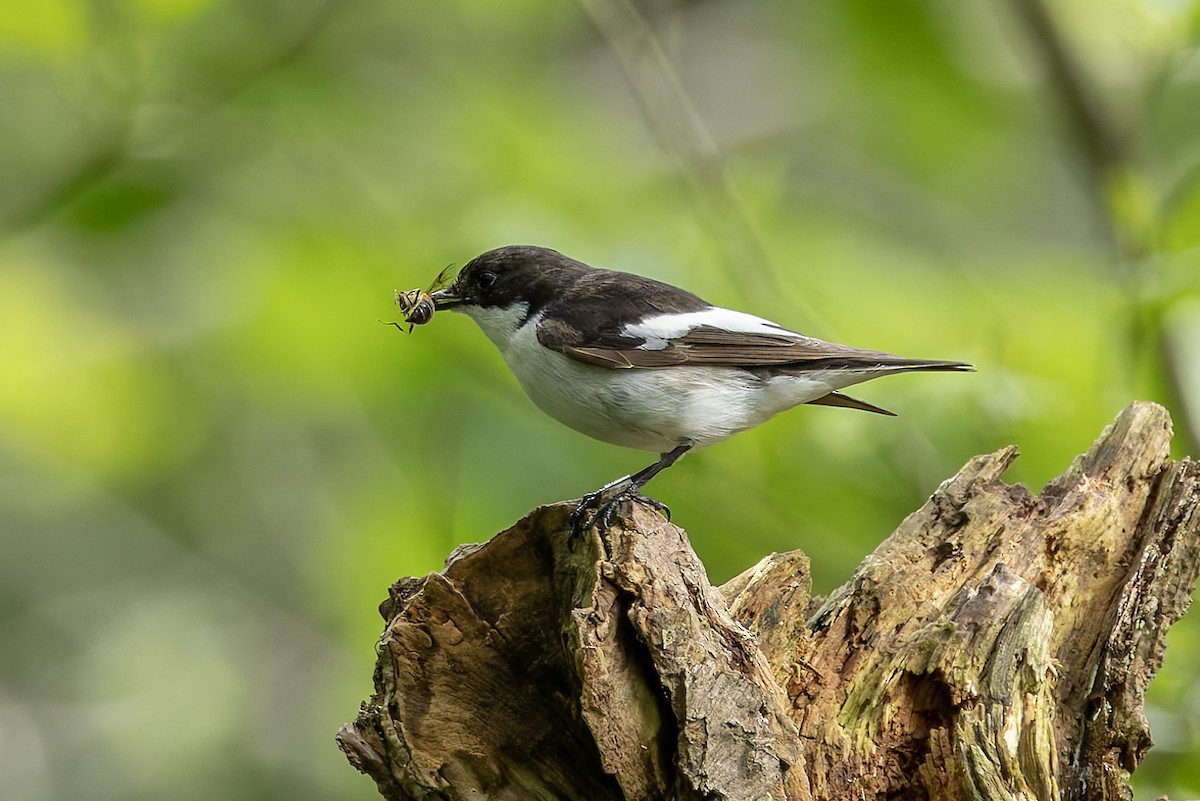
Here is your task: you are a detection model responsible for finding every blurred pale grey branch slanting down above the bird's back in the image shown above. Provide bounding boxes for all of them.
[580,0,827,327]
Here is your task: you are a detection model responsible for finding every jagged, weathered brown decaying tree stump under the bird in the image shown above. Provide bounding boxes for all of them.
[338,403,1200,801]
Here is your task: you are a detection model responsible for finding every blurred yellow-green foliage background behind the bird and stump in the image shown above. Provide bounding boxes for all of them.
[0,0,1200,801]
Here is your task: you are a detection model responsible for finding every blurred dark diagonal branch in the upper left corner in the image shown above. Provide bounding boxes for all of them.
[0,0,349,235]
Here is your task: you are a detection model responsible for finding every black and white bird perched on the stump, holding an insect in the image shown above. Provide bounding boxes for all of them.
[424,245,974,538]
